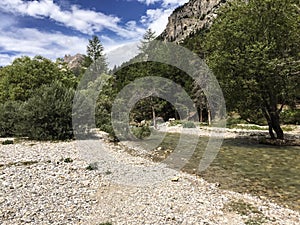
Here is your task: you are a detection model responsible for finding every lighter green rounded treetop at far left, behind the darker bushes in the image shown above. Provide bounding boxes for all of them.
[0,56,77,103]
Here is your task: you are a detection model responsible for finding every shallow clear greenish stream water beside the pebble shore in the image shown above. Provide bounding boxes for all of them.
[153,134,300,211]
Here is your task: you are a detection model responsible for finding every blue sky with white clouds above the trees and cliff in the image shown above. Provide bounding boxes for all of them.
[0,0,188,67]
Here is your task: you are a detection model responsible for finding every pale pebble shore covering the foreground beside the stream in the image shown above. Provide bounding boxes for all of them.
[0,137,300,225]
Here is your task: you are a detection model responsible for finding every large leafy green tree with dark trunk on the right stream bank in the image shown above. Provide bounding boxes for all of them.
[205,0,300,139]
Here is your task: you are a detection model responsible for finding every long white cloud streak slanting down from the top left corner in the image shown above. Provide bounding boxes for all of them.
[0,0,144,38]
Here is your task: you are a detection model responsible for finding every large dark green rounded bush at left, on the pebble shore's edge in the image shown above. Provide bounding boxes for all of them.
[17,82,74,140]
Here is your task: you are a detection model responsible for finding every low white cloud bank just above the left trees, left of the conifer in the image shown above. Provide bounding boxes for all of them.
[0,28,87,65]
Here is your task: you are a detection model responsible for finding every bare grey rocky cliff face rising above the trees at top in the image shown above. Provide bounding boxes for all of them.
[160,0,227,43]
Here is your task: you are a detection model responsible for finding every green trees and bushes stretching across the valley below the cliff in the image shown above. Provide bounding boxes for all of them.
[0,0,300,140]
